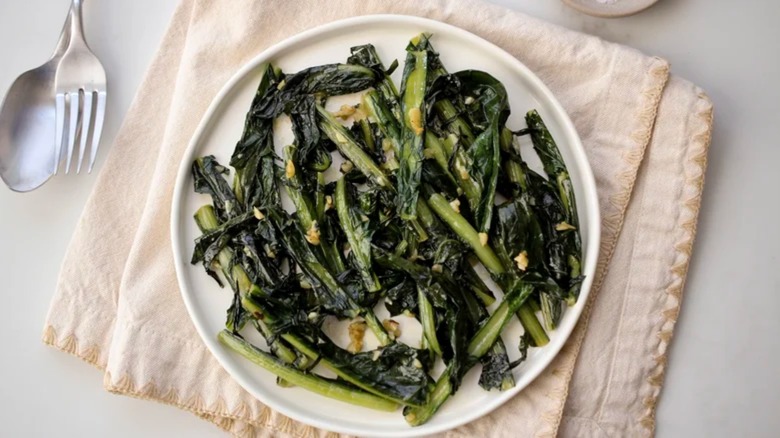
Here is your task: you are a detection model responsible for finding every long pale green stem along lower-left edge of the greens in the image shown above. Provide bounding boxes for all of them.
[217,330,398,412]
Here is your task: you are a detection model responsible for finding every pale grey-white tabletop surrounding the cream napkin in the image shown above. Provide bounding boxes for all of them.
[0,0,780,437]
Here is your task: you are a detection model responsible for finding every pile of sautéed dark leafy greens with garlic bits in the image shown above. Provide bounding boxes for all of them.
[192,34,583,426]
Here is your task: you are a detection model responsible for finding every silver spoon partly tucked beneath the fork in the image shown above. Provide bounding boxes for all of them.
[0,10,70,192]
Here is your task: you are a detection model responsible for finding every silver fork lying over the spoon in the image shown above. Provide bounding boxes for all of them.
[54,0,107,174]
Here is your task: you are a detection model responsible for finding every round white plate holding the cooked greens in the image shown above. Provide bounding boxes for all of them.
[171,15,599,437]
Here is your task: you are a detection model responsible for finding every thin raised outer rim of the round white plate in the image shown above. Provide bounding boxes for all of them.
[170,14,601,438]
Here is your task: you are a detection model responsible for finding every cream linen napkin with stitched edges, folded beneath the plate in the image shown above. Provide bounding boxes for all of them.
[43,0,712,437]
